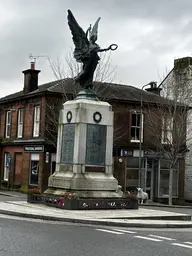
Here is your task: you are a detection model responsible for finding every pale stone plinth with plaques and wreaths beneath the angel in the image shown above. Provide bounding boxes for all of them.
[45,99,122,198]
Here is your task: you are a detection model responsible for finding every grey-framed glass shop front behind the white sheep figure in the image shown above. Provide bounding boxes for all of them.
[124,150,182,202]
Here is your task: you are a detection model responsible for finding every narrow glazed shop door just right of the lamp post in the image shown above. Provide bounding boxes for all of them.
[145,159,153,200]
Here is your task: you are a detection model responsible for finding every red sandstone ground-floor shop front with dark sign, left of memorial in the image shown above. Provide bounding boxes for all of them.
[1,144,56,191]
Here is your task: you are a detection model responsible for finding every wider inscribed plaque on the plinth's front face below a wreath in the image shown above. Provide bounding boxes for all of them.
[86,124,107,165]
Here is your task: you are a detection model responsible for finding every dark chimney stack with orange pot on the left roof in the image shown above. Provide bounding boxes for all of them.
[22,62,41,93]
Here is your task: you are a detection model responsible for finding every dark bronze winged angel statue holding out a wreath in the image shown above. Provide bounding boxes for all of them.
[67,10,118,89]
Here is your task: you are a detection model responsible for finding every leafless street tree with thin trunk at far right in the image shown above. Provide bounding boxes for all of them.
[145,67,192,204]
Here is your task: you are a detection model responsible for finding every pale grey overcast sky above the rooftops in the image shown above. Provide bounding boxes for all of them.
[0,0,192,97]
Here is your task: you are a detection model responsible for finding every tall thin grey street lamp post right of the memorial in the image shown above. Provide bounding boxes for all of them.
[139,82,156,191]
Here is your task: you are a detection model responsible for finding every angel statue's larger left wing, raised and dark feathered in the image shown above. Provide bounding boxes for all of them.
[67,10,89,62]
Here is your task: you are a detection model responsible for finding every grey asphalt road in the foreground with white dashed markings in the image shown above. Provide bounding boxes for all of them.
[0,215,192,256]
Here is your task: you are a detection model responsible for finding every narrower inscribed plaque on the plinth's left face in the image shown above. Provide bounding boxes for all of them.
[61,124,75,164]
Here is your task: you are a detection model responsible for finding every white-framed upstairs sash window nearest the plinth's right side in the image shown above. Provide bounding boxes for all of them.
[131,113,143,142]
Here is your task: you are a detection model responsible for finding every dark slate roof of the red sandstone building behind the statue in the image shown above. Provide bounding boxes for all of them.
[0,78,176,104]
